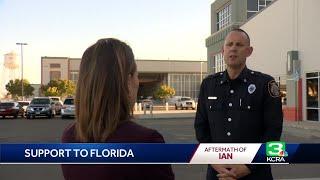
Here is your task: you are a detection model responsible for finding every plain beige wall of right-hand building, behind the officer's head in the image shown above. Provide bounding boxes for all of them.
[241,0,320,120]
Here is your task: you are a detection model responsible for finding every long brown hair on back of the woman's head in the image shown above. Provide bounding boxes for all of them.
[75,38,137,142]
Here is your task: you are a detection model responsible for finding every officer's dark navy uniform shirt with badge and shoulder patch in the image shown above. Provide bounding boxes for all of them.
[194,67,283,143]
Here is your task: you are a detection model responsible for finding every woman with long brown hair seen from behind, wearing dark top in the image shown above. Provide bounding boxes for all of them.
[62,38,174,180]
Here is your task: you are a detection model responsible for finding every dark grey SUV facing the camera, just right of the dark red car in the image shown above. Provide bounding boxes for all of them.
[26,97,56,119]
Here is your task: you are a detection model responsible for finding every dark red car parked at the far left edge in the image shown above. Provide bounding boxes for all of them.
[0,102,24,118]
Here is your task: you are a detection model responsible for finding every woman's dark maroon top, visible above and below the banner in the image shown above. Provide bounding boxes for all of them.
[62,121,174,180]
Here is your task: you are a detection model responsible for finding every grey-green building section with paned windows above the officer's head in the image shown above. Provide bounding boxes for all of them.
[206,0,272,73]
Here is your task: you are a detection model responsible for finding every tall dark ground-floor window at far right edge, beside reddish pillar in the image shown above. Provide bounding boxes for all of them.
[306,72,320,121]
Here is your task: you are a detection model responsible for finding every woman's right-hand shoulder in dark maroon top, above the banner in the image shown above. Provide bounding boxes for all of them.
[108,121,164,143]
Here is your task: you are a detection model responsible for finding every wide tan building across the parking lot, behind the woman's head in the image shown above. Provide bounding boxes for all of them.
[41,57,207,98]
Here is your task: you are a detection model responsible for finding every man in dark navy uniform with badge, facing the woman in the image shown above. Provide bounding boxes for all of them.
[194,29,283,180]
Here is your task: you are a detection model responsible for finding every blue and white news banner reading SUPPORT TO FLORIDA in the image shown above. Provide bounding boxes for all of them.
[0,141,320,164]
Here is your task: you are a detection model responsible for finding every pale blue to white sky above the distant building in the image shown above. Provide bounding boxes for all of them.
[0,0,214,83]
